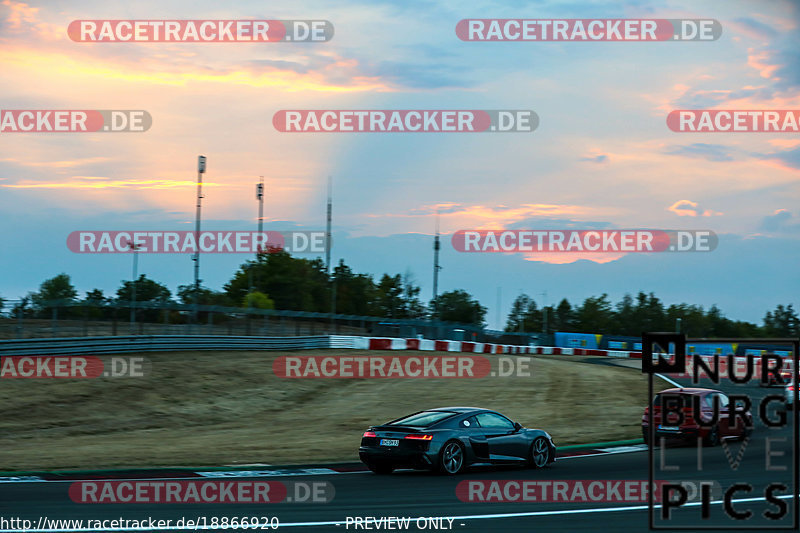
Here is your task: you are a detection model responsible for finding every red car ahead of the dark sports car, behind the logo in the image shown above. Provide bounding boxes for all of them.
[642,388,753,446]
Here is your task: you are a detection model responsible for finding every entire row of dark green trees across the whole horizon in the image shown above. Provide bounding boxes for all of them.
[0,251,800,337]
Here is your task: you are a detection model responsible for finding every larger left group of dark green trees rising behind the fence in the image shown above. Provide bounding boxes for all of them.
[0,251,486,327]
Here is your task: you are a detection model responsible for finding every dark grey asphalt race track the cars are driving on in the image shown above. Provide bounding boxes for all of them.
[0,364,794,532]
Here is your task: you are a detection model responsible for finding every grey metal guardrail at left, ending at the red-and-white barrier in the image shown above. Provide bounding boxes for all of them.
[0,335,331,356]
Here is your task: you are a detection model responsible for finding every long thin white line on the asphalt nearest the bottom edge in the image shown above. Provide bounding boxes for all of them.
[0,494,792,533]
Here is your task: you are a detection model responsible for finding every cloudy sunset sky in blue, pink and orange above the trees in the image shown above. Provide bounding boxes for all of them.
[0,0,800,328]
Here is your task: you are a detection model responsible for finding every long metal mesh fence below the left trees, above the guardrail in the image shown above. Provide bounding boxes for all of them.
[0,301,538,345]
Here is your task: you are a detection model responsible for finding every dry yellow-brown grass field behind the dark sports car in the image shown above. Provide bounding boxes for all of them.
[0,350,647,471]
